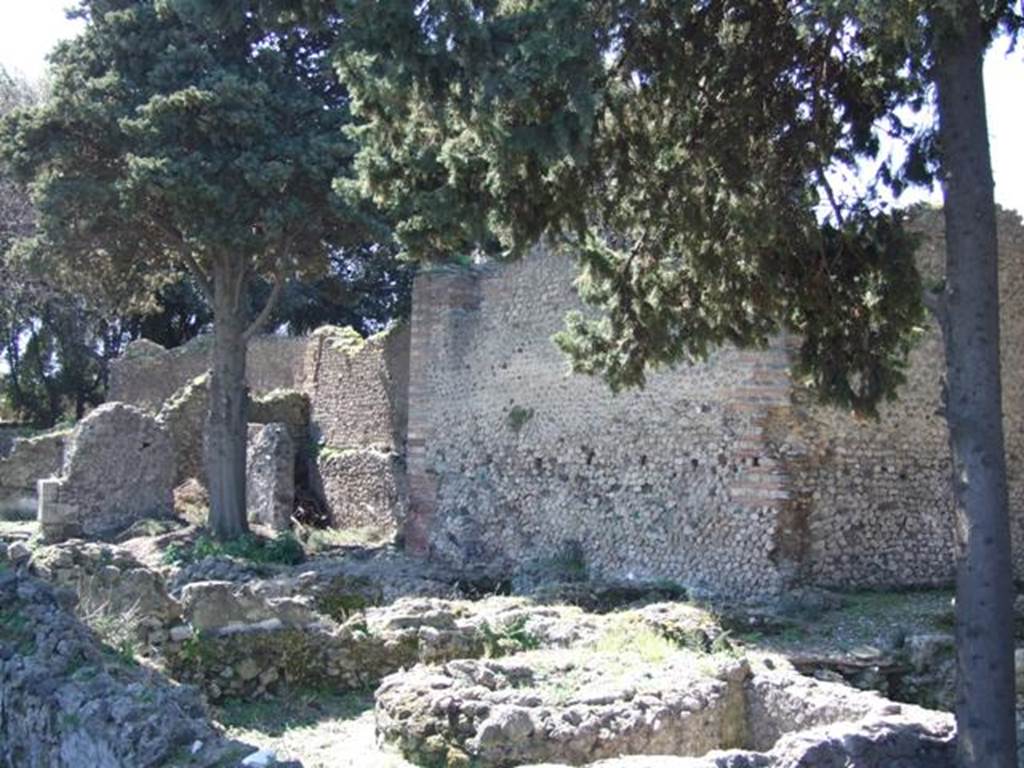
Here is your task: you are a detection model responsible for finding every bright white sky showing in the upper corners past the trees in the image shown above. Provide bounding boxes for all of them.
[0,0,1024,215]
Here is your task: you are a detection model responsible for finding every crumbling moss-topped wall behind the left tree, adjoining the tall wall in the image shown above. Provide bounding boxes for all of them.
[103,326,410,535]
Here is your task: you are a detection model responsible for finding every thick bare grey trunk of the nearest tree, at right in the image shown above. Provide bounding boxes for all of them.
[935,0,1017,768]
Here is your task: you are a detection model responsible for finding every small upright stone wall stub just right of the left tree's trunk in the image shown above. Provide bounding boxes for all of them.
[246,424,296,530]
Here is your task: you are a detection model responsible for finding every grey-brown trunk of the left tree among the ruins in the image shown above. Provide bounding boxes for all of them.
[205,263,249,541]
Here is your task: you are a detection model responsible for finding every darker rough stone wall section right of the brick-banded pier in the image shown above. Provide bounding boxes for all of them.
[793,205,1024,587]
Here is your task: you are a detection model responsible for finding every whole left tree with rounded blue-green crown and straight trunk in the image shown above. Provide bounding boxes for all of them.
[0,0,376,538]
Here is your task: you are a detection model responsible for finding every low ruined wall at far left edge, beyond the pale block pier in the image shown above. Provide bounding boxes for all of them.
[0,430,70,519]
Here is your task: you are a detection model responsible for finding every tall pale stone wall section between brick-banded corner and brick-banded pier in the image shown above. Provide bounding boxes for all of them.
[407,256,794,594]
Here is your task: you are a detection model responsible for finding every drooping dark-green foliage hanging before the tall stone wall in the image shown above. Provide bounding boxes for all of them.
[336,0,962,412]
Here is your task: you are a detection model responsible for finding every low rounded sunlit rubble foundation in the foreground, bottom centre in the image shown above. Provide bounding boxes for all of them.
[376,651,953,768]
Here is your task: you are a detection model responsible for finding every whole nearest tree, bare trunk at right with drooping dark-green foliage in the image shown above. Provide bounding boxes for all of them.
[323,0,1022,768]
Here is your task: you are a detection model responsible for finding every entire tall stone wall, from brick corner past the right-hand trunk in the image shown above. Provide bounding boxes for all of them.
[406,207,1024,595]
